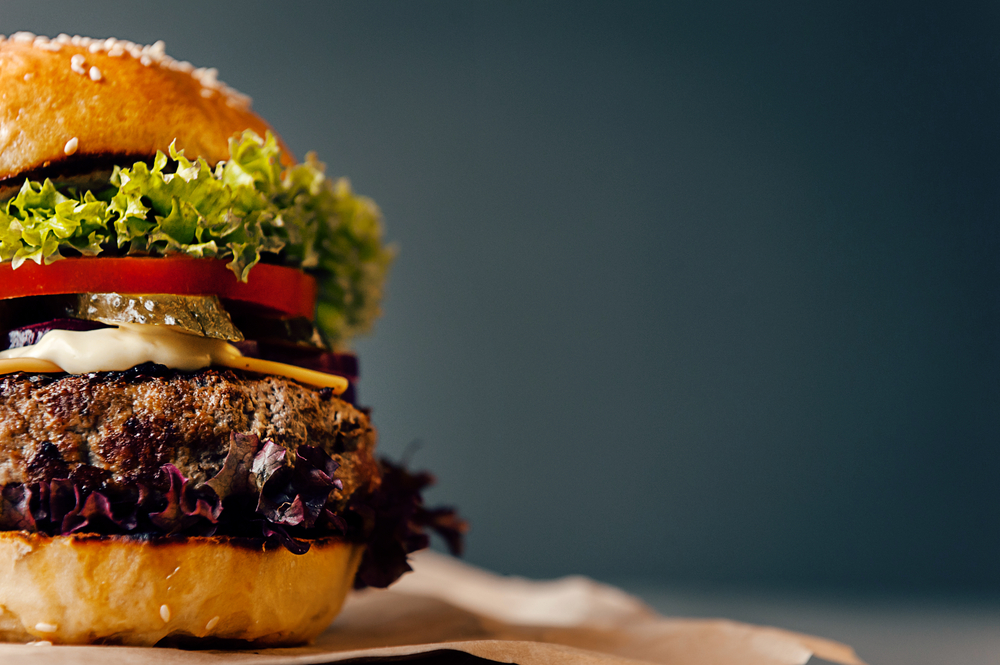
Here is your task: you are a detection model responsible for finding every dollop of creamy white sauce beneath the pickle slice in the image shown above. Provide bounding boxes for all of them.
[0,323,242,374]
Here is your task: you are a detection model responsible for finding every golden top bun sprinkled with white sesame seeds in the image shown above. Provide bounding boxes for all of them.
[0,32,288,183]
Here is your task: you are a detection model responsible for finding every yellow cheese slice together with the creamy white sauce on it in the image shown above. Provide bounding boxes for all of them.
[0,323,347,395]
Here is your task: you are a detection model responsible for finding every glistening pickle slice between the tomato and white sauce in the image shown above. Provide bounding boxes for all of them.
[69,293,243,342]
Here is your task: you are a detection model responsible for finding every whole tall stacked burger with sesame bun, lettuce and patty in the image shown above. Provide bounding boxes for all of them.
[0,32,465,646]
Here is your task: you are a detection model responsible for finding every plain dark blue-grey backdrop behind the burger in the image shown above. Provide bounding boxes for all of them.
[0,0,1000,592]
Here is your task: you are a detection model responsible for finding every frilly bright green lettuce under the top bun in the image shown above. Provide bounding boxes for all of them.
[0,131,392,341]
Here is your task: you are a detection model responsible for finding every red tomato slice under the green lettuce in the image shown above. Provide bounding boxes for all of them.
[0,256,316,321]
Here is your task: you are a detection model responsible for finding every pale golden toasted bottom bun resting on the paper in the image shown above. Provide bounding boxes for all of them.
[0,531,363,646]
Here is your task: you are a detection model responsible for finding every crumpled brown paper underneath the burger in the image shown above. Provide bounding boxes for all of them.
[0,552,864,665]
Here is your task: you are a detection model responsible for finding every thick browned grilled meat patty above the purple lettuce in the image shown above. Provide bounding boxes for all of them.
[0,364,379,501]
